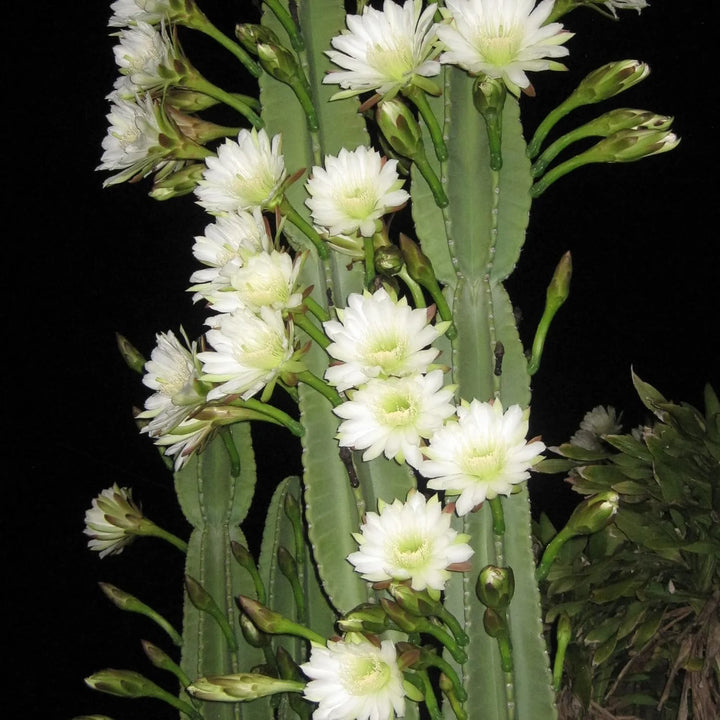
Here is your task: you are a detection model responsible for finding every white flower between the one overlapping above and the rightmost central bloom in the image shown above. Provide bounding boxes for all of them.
[334,370,455,467]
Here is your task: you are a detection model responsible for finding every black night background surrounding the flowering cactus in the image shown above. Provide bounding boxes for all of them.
[8,0,720,720]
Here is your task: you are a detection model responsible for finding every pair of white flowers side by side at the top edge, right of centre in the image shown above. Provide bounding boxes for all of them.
[324,0,572,97]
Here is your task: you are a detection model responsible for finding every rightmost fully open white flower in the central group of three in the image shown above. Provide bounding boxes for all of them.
[419,400,545,515]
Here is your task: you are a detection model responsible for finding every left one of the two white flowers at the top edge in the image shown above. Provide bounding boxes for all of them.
[323,0,440,98]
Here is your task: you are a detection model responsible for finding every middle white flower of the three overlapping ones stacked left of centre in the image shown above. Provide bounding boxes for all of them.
[201,250,306,313]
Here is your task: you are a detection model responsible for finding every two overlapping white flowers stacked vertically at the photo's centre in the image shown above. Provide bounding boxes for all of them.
[324,288,454,467]
